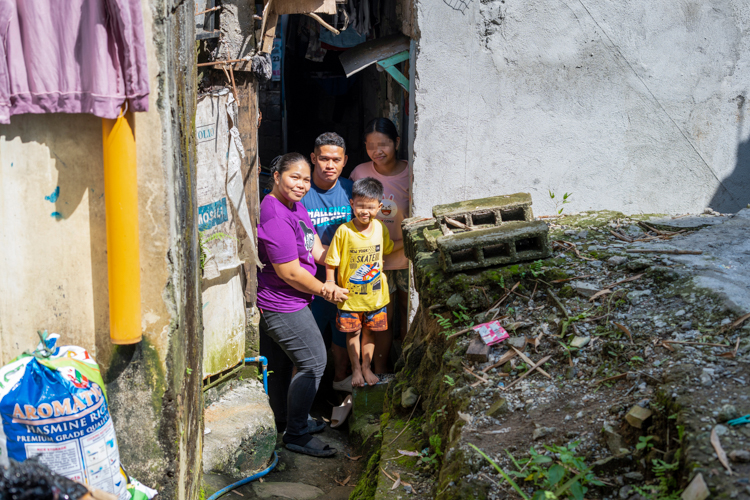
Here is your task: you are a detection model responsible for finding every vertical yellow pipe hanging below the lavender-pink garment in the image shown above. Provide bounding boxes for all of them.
[102,112,142,344]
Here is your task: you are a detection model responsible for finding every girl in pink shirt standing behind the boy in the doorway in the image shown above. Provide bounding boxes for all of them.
[350,118,411,373]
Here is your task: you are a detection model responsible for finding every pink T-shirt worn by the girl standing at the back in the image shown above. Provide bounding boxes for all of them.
[349,161,411,271]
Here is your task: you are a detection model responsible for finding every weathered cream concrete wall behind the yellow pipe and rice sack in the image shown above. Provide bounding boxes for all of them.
[0,0,203,499]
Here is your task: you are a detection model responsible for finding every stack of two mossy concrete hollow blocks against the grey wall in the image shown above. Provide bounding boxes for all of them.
[403,193,551,272]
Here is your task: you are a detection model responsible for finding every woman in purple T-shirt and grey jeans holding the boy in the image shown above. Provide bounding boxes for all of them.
[258,153,348,457]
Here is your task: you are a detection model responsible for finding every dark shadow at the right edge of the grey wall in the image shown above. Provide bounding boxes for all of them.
[708,96,750,213]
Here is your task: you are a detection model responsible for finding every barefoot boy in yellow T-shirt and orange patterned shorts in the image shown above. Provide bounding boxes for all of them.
[326,177,403,387]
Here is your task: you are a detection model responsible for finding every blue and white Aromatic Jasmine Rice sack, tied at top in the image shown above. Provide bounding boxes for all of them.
[0,332,155,500]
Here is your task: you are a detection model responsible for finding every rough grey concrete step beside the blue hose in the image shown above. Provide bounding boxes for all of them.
[203,380,276,479]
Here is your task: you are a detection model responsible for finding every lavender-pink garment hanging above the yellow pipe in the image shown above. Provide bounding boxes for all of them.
[0,0,149,123]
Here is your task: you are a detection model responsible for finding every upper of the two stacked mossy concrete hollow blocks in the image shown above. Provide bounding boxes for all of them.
[432,193,534,235]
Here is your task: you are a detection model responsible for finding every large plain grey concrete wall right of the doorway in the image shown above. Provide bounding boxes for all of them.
[413,0,750,215]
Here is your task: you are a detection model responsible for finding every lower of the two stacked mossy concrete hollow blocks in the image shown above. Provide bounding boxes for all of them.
[436,221,551,272]
